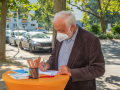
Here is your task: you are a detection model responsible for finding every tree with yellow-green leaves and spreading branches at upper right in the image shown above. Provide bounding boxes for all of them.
[67,0,120,32]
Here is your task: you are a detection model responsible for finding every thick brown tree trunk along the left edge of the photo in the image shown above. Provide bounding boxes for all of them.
[0,0,7,61]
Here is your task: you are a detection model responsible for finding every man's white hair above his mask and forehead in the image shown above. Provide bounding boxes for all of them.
[54,11,76,27]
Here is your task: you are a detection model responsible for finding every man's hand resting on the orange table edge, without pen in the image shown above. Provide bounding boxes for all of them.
[57,65,71,76]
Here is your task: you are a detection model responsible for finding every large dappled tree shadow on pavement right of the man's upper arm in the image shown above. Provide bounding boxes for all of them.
[101,40,120,65]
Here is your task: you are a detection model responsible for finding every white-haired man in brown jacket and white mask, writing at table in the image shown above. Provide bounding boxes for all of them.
[40,11,105,90]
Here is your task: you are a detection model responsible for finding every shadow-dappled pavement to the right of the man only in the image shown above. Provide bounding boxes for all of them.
[97,40,120,90]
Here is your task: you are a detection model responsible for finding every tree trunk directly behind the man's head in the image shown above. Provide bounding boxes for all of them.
[52,0,66,48]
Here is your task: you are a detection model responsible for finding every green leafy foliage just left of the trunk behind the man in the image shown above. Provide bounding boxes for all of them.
[30,0,54,29]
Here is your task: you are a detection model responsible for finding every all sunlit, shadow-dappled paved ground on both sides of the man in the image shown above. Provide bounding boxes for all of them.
[0,40,120,90]
